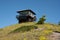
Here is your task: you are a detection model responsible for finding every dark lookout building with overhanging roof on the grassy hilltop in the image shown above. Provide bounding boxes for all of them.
[16,10,36,23]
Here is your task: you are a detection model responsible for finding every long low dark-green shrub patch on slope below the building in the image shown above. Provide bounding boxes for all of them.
[12,25,38,32]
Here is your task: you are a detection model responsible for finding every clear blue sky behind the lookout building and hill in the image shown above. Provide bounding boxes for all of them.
[0,0,60,28]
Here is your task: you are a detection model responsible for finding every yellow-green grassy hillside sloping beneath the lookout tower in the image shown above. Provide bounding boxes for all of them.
[0,22,60,40]
